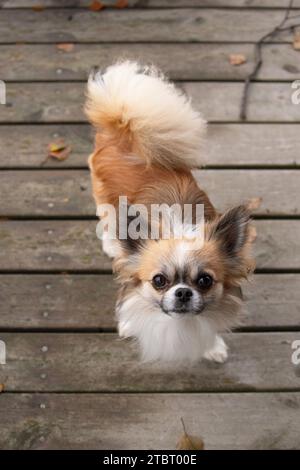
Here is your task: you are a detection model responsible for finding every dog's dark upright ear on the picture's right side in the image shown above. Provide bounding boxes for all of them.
[211,205,250,257]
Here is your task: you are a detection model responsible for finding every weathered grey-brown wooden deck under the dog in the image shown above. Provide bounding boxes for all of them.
[0,0,300,449]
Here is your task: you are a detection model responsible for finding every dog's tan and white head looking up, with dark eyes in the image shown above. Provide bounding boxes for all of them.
[115,206,253,359]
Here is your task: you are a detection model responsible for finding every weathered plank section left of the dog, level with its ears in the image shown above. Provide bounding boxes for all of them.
[0,220,111,271]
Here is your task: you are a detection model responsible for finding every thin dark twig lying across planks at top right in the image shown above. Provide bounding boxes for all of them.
[240,0,294,121]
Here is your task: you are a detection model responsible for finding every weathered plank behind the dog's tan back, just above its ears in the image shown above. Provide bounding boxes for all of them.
[0,170,300,217]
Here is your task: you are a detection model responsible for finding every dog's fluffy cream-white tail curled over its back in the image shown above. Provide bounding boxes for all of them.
[85,62,206,168]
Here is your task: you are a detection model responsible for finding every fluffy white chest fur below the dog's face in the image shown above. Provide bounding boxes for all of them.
[117,289,216,363]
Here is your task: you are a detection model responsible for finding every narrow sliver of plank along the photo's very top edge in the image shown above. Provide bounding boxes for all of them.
[0,0,300,8]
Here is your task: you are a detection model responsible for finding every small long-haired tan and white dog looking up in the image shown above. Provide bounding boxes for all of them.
[85,61,254,364]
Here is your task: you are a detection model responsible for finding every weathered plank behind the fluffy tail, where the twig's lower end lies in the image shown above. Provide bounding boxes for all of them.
[0,82,300,123]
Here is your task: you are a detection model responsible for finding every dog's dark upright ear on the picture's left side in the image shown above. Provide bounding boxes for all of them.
[118,204,149,254]
